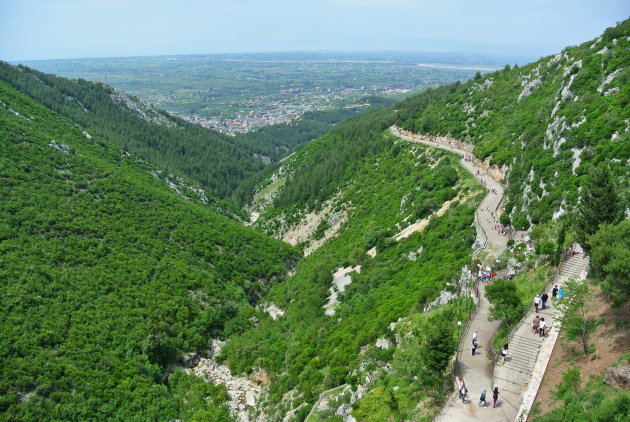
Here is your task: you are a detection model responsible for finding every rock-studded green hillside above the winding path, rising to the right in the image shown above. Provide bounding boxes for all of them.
[395,20,630,229]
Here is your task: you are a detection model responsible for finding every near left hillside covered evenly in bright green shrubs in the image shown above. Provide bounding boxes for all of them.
[0,82,297,421]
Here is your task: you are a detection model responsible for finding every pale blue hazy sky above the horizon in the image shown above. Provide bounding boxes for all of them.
[0,0,630,61]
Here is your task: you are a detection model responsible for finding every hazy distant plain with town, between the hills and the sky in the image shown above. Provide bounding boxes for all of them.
[25,52,513,135]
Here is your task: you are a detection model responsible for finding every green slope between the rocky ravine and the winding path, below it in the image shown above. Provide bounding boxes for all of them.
[215,83,482,420]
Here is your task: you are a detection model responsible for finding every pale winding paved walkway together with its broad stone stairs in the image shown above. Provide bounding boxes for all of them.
[390,127,589,422]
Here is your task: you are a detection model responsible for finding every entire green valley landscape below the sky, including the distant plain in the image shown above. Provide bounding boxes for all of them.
[0,20,630,422]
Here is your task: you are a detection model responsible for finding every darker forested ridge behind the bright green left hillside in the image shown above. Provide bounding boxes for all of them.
[0,62,264,198]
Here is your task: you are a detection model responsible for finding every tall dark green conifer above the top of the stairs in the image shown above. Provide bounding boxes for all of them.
[575,163,624,253]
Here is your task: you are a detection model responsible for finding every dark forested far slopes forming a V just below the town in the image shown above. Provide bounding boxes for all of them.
[0,61,390,203]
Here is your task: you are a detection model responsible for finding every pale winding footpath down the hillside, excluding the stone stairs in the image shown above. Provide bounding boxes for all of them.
[390,126,520,422]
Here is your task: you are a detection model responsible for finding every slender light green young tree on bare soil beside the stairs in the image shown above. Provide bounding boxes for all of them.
[559,280,595,354]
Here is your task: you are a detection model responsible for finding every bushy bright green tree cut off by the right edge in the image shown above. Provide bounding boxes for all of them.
[588,220,630,304]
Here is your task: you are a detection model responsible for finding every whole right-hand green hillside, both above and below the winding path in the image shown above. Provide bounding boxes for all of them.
[216,22,630,420]
